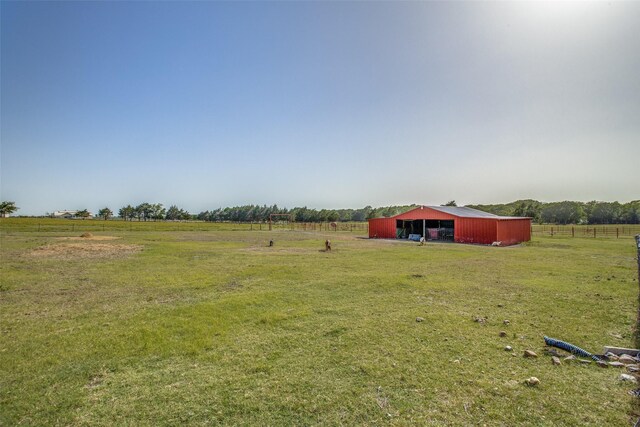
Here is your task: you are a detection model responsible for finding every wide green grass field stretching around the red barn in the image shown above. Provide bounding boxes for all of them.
[0,219,638,426]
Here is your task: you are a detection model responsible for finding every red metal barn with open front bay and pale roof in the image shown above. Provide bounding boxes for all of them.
[369,206,531,246]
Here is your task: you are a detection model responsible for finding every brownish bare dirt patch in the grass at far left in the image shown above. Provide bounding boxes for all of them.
[29,242,142,260]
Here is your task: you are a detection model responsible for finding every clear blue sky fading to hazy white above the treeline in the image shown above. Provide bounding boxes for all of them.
[0,1,640,215]
